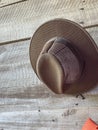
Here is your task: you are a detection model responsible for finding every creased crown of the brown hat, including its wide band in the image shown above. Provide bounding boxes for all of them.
[37,38,83,93]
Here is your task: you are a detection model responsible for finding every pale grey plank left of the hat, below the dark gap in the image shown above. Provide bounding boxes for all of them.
[0,41,39,95]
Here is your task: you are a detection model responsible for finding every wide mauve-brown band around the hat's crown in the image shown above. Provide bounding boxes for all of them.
[47,38,84,84]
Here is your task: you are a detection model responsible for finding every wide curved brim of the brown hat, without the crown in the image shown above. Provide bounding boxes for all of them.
[29,19,98,94]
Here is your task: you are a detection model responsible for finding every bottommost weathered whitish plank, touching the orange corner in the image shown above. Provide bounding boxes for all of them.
[0,107,98,130]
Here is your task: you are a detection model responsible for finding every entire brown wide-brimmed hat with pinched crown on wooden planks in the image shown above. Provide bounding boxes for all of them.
[30,19,98,93]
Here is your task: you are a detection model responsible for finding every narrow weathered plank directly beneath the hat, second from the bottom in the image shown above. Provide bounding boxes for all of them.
[0,94,98,113]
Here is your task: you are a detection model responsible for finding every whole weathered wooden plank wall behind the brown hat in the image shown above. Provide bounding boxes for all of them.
[0,0,98,130]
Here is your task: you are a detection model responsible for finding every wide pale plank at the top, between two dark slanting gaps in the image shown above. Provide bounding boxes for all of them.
[0,0,98,42]
